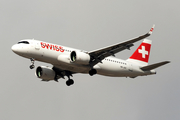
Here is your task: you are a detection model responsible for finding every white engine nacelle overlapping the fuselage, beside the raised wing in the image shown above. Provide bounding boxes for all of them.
[70,51,90,65]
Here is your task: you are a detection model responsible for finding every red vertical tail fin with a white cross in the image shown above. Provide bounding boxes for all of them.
[128,39,152,66]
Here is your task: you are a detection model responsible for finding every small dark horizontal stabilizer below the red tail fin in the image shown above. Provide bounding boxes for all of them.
[141,61,170,71]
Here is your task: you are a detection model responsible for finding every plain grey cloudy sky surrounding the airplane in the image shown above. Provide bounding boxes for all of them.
[0,0,180,120]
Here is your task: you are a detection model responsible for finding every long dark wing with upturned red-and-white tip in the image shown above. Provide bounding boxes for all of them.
[88,25,155,67]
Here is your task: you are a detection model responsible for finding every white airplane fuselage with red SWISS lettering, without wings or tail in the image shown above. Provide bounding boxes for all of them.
[12,40,155,77]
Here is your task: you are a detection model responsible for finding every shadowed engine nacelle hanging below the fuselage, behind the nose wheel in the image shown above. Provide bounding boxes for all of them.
[35,66,56,81]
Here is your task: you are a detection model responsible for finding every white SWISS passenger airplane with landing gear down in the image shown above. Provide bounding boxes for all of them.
[11,25,170,86]
